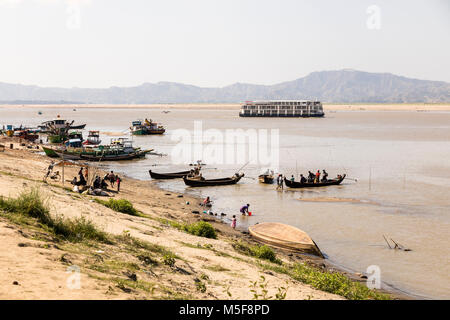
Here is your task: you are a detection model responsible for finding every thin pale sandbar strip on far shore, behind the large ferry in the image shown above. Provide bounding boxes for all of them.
[0,103,450,112]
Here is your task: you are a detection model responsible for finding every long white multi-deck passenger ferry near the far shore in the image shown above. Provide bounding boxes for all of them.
[239,100,325,117]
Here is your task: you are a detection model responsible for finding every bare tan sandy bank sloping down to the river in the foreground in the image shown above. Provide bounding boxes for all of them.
[0,136,404,299]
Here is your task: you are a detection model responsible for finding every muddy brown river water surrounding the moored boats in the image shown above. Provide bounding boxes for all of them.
[0,107,450,299]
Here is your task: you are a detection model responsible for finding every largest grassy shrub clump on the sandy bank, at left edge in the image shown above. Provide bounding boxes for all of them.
[0,188,109,242]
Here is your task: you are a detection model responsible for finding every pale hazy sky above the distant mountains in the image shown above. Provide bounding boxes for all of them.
[0,0,450,87]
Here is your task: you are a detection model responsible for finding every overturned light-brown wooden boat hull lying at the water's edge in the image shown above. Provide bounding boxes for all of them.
[248,222,323,258]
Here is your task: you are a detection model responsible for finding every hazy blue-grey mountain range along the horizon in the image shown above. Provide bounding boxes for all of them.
[0,69,450,104]
